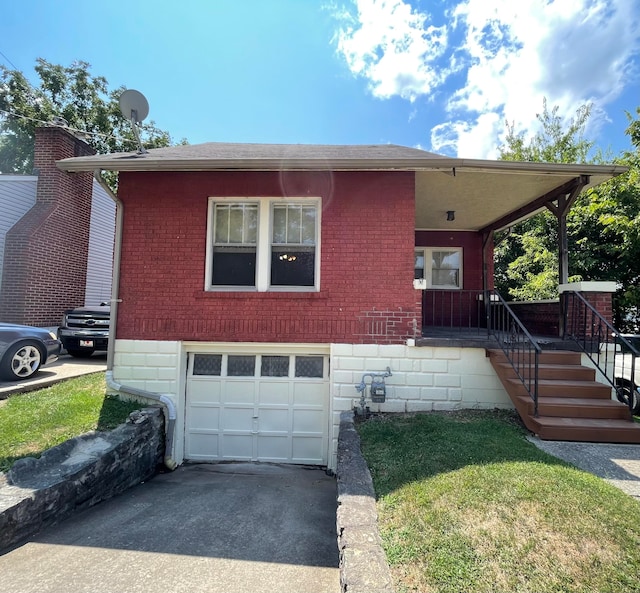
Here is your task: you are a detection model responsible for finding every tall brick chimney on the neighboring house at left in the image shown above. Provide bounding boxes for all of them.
[0,127,95,327]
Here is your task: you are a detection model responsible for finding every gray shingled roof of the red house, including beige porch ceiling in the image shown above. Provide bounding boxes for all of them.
[57,142,626,232]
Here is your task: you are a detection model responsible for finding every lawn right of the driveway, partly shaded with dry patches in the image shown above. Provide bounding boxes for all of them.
[358,411,640,593]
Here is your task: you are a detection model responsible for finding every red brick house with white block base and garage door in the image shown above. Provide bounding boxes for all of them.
[58,143,620,468]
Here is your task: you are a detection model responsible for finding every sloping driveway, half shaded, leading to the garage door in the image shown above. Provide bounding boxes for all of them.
[0,463,340,593]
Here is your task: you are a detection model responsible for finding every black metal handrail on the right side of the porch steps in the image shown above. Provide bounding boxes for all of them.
[563,291,640,417]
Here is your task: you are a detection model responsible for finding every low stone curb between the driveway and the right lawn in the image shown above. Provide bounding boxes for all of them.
[336,412,393,593]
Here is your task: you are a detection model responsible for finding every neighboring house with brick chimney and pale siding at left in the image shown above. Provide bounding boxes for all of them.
[0,126,115,327]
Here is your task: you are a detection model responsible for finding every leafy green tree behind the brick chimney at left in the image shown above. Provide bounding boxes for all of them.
[0,58,178,174]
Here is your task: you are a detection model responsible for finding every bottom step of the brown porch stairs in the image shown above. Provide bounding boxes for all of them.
[531,416,640,443]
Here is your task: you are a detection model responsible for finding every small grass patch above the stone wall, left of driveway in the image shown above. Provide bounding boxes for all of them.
[0,373,140,471]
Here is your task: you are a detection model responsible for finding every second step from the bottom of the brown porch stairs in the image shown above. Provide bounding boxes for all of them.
[514,395,631,421]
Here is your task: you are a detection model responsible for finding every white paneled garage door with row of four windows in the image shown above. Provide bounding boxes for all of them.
[185,352,329,465]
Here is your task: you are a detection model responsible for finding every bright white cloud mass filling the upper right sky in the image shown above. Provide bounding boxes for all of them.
[339,0,640,158]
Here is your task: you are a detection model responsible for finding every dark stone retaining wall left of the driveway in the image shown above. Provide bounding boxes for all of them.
[0,408,164,550]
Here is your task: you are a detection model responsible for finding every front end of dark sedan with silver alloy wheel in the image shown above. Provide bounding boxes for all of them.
[0,323,60,381]
